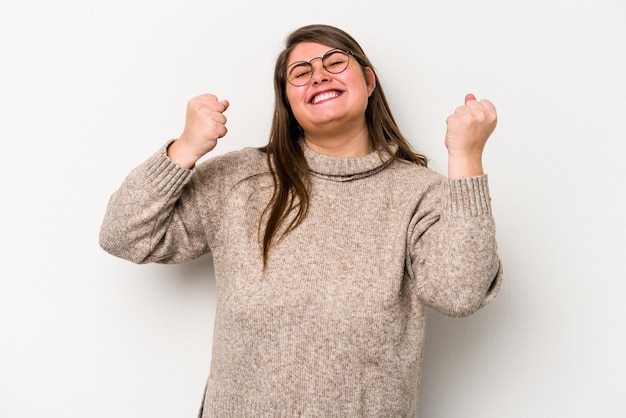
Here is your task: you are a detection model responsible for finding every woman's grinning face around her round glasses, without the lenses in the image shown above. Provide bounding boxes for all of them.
[285,42,375,140]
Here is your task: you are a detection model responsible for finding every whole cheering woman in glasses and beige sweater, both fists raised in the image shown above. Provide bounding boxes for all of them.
[100,25,502,418]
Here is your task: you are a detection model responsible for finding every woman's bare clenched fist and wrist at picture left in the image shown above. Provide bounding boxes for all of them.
[167,94,229,168]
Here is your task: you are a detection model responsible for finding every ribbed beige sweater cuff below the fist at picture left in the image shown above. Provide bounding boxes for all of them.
[143,141,192,195]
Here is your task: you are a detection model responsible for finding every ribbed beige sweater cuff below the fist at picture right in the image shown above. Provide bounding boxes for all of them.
[446,174,491,217]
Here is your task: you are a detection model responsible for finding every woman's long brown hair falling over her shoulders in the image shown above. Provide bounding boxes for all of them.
[259,25,428,265]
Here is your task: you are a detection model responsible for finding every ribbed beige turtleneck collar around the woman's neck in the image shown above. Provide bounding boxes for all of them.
[301,141,397,182]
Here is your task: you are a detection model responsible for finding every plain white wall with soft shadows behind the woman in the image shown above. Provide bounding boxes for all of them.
[0,0,626,418]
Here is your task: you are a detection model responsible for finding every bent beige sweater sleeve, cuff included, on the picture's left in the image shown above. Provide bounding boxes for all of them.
[100,142,209,263]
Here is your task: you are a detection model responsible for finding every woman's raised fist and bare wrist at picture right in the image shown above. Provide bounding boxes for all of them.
[445,94,498,178]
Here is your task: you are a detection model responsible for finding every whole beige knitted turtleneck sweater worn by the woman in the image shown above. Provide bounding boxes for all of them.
[100,141,502,418]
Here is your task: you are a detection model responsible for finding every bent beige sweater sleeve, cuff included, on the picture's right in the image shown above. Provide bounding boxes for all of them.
[407,175,502,317]
